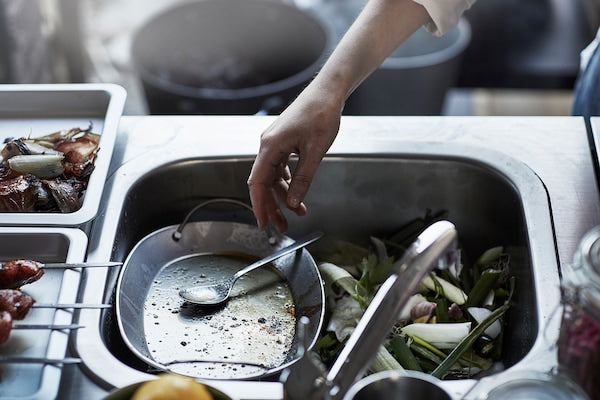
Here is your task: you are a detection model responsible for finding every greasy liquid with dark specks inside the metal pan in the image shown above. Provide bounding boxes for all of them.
[144,254,296,379]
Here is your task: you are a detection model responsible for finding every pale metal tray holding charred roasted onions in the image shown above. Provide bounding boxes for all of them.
[0,84,126,227]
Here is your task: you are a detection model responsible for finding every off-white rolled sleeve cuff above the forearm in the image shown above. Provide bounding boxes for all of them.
[413,0,476,36]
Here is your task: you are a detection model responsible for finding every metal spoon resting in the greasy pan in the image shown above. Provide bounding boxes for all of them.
[179,231,323,306]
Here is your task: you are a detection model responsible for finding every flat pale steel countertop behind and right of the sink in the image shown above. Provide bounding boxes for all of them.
[59,116,600,399]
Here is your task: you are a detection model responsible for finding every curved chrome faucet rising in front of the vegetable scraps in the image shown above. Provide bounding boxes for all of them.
[281,221,458,400]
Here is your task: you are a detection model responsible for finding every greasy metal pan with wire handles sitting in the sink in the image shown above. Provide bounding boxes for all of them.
[116,211,325,379]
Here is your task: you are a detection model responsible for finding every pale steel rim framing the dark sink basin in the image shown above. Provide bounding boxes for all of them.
[78,141,560,399]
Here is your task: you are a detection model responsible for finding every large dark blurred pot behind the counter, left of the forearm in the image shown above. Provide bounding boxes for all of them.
[132,0,331,114]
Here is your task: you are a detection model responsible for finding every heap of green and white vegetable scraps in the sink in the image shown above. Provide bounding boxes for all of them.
[313,211,515,379]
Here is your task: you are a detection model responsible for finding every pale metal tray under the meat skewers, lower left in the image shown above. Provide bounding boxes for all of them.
[0,227,88,400]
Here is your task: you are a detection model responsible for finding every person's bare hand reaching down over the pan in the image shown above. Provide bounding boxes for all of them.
[248,86,342,232]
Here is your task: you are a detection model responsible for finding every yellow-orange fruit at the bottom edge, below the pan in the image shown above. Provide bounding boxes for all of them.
[131,373,213,400]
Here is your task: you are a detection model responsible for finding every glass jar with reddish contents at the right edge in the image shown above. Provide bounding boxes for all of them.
[558,227,600,400]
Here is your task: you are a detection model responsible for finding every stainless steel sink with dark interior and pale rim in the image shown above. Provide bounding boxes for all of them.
[75,142,560,399]
